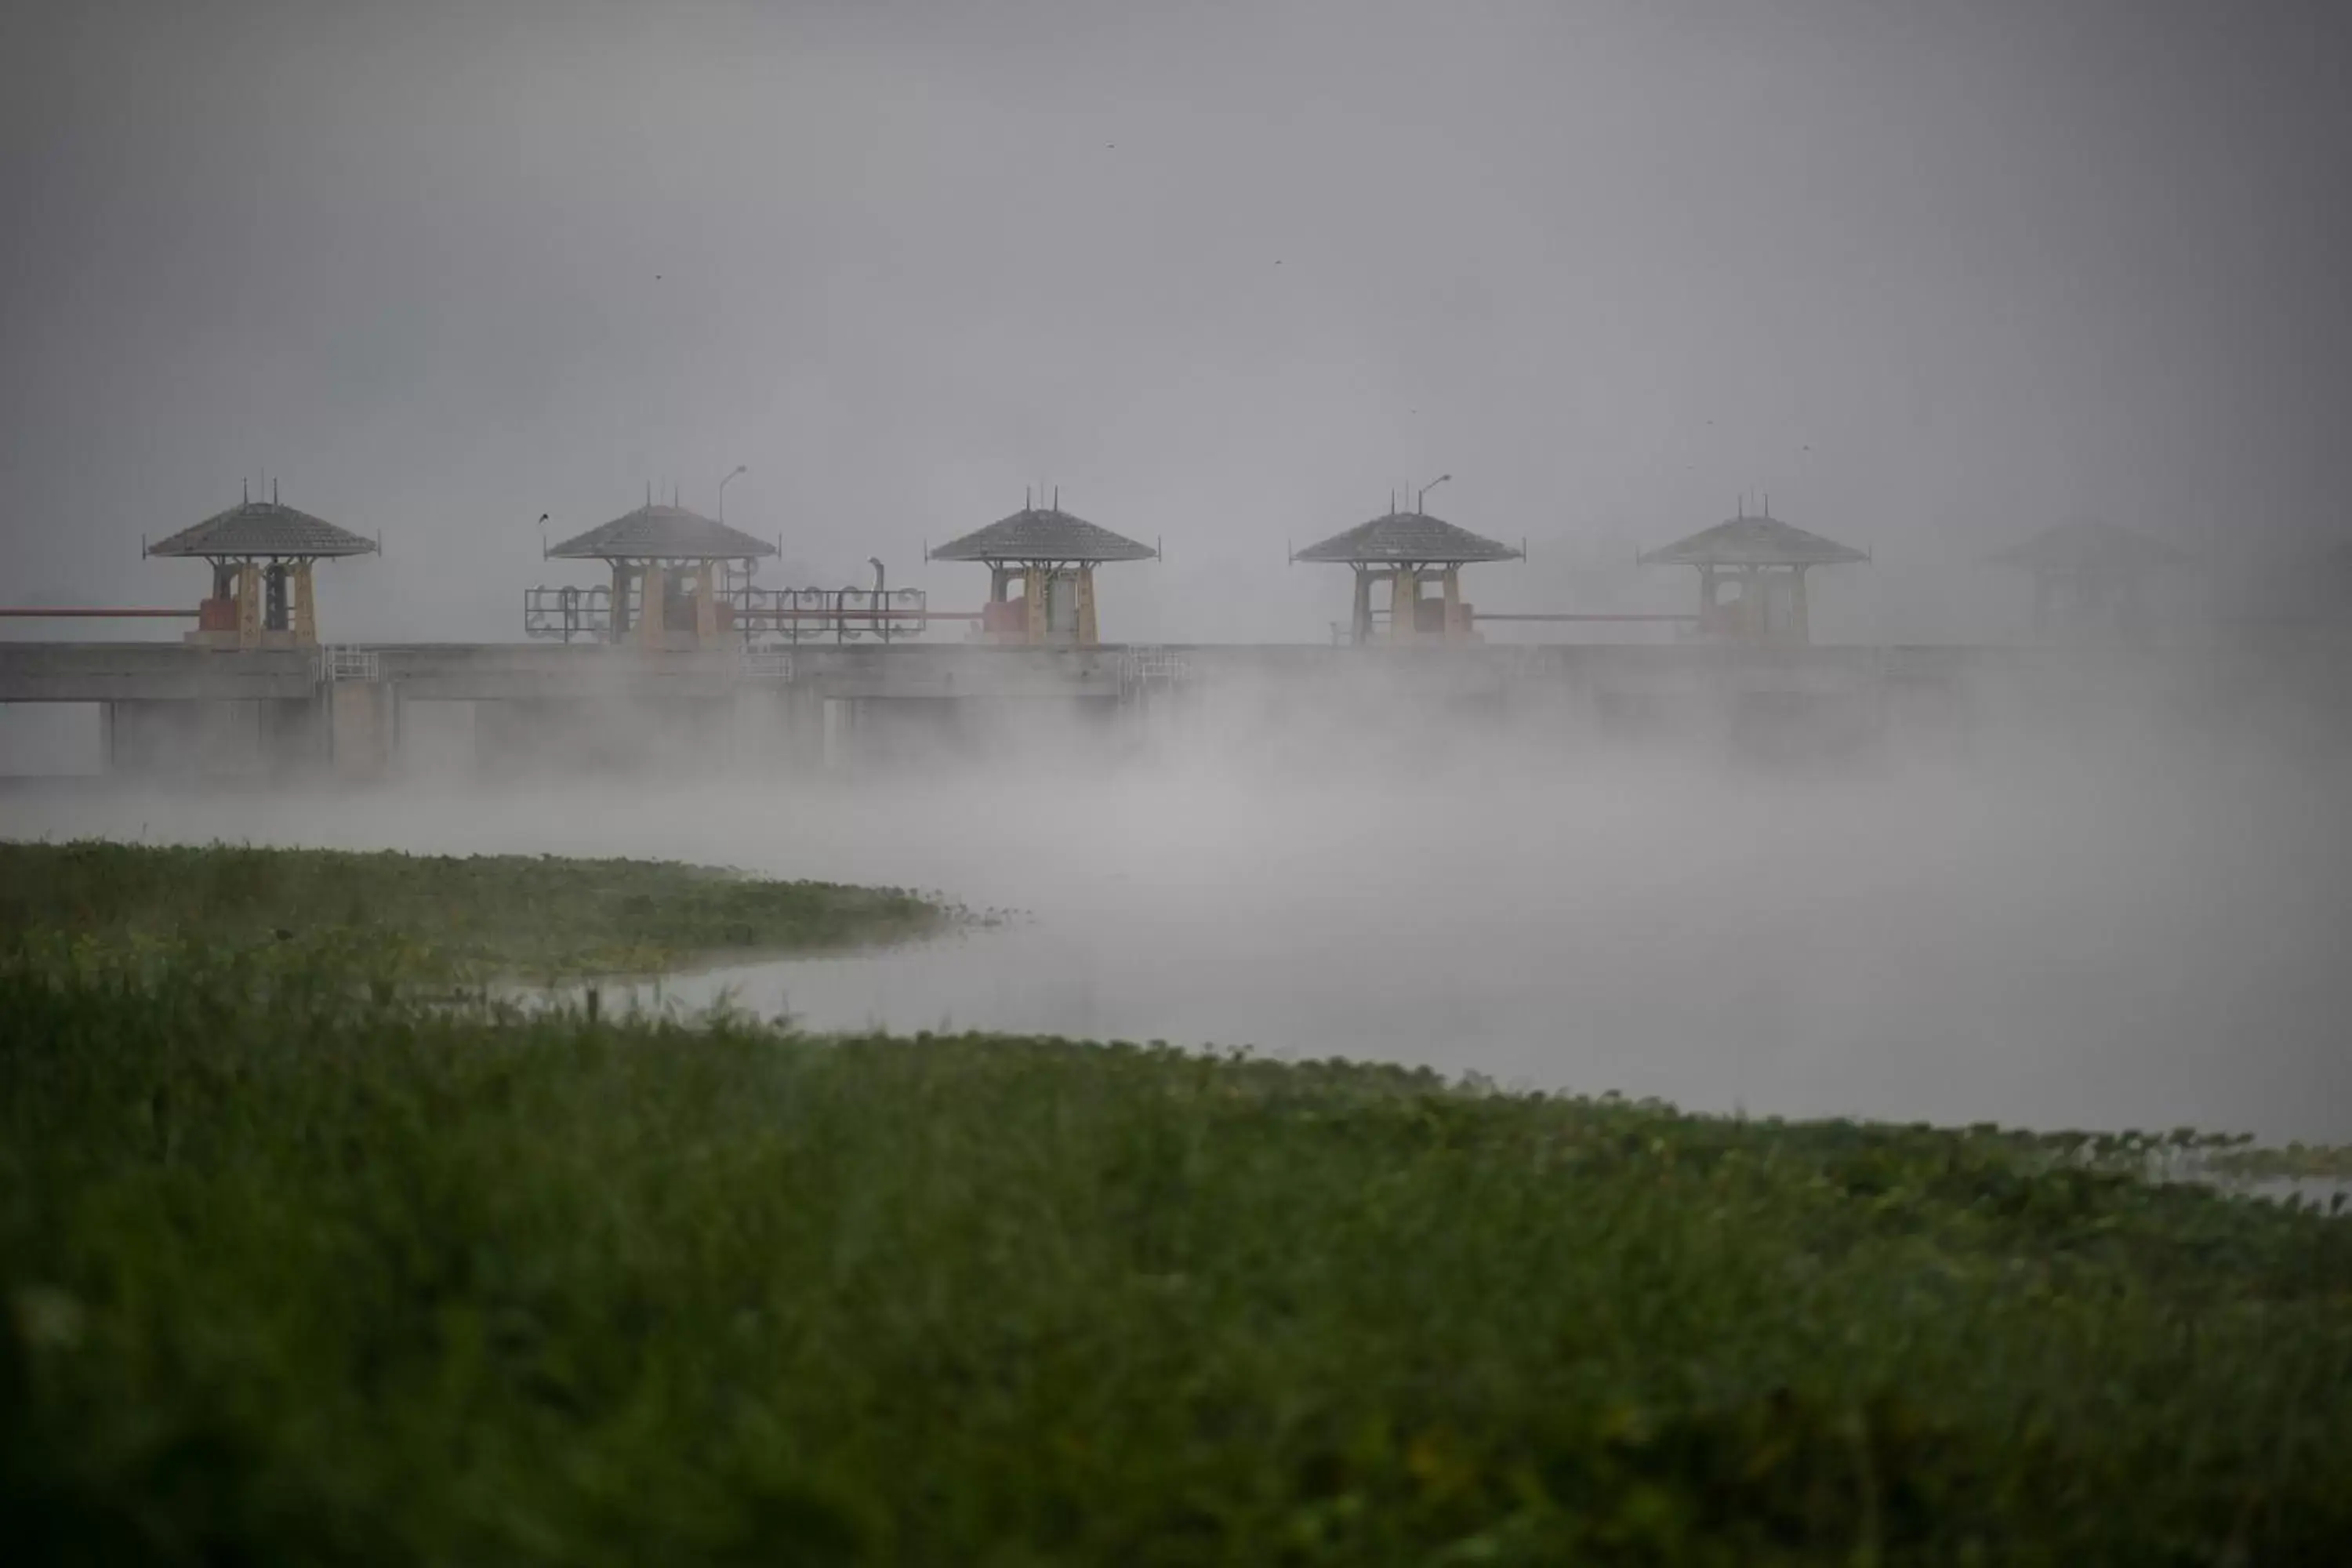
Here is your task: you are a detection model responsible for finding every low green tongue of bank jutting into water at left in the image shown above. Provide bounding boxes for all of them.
[0,841,946,980]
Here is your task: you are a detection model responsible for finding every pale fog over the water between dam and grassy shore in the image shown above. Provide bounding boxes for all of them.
[0,686,2352,1138]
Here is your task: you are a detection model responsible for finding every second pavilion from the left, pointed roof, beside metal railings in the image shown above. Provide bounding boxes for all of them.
[541,496,776,649]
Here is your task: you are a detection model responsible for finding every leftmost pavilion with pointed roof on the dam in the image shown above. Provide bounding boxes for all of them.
[143,485,376,649]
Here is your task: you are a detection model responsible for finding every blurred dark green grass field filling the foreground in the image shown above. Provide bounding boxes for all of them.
[0,851,2352,1563]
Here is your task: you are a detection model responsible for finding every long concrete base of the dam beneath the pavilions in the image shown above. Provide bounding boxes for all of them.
[0,637,2352,779]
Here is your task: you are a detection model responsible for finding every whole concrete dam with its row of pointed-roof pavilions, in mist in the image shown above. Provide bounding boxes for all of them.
[0,496,2352,781]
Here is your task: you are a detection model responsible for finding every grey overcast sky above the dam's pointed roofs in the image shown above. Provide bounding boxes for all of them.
[0,0,2352,640]
